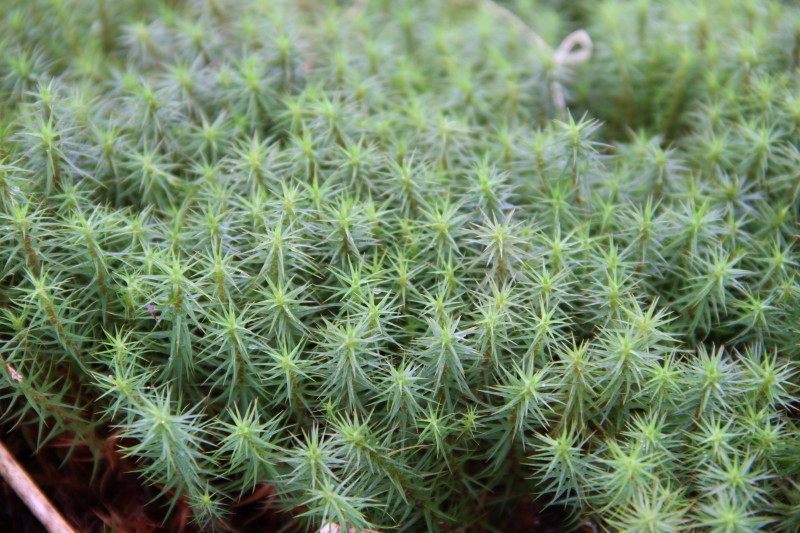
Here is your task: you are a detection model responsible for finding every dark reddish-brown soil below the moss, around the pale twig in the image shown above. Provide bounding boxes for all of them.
[0,425,290,533]
